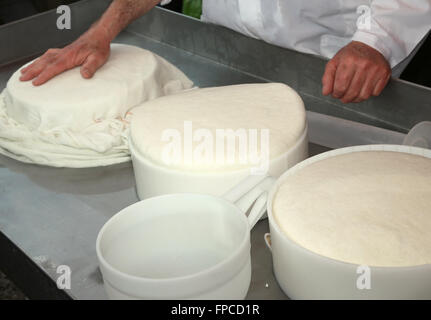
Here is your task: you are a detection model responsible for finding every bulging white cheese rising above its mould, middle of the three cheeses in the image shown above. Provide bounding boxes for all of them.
[131,83,306,172]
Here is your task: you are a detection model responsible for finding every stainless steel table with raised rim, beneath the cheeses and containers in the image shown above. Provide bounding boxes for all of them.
[0,0,431,299]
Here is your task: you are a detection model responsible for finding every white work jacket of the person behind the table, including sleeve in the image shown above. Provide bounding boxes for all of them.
[164,0,431,74]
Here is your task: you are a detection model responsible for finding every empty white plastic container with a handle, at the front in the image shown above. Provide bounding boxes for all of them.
[96,176,272,299]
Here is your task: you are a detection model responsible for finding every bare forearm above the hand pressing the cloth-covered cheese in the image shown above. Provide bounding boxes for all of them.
[91,0,160,41]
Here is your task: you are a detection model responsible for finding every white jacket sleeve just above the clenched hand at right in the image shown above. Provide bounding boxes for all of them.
[352,0,431,68]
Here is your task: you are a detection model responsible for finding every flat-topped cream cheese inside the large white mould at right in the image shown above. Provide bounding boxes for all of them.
[273,151,431,267]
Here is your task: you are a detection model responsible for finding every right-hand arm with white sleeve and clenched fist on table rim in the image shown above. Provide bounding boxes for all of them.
[322,0,431,103]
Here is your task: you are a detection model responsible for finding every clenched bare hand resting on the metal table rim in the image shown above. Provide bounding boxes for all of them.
[322,41,391,103]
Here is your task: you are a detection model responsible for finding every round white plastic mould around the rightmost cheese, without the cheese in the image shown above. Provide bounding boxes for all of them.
[265,145,431,299]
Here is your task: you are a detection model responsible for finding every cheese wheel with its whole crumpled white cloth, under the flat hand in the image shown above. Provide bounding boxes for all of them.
[0,44,193,167]
